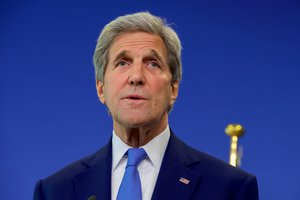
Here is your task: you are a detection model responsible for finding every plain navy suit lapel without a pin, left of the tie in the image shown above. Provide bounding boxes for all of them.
[73,140,112,200]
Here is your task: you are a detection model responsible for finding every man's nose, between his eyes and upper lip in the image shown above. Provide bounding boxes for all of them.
[128,63,145,86]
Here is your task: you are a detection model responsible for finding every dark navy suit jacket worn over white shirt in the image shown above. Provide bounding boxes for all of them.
[34,133,258,200]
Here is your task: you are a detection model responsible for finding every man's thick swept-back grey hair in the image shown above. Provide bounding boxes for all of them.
[93,12,182,82]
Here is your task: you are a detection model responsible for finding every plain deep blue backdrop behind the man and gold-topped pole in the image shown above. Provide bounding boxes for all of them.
[0,0,300,200]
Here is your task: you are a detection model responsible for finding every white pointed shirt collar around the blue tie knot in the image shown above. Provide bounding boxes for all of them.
[112,125,170,170]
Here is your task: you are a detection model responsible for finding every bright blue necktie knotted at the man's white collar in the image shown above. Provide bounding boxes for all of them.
[117,148,147,200]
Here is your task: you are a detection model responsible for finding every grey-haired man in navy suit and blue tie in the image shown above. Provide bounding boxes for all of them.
[34,12,258,200]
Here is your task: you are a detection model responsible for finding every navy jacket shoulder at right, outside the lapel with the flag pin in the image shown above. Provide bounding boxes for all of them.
[170,135,258,200]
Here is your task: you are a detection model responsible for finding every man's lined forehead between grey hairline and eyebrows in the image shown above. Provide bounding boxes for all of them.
[109,32,167,58]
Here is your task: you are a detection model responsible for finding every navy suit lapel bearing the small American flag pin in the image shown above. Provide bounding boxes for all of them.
[152,132,200,200]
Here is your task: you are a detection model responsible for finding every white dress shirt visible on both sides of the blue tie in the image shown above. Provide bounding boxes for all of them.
[111,126,170,200]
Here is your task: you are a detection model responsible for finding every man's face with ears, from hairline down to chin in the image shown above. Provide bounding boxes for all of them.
[97,32,178,128]
